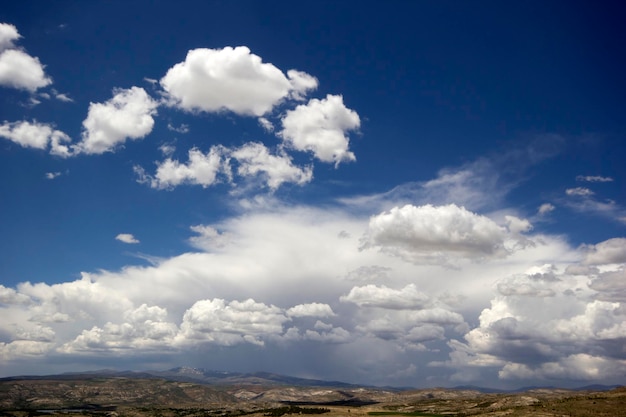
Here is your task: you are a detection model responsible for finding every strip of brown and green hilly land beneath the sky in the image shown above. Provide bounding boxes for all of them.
[0,367,626,417]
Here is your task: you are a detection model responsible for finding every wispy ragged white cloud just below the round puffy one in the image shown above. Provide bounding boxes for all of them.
[230,143,313,190]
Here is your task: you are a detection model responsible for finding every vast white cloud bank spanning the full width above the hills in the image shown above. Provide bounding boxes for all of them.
[0,190,626,384]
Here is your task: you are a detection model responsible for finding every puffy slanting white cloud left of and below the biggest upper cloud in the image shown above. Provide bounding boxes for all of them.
[78,87,158,154]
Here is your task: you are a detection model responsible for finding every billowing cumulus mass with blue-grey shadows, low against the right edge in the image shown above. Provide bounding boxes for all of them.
[436,239,626,381]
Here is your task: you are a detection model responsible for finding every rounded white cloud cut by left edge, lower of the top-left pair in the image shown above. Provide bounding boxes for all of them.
[0,49,52,92]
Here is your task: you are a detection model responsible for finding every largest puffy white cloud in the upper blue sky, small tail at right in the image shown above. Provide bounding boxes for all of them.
[160,46,317,116]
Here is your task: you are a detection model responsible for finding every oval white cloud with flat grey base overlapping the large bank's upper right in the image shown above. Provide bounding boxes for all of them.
[362,204,530,264]
